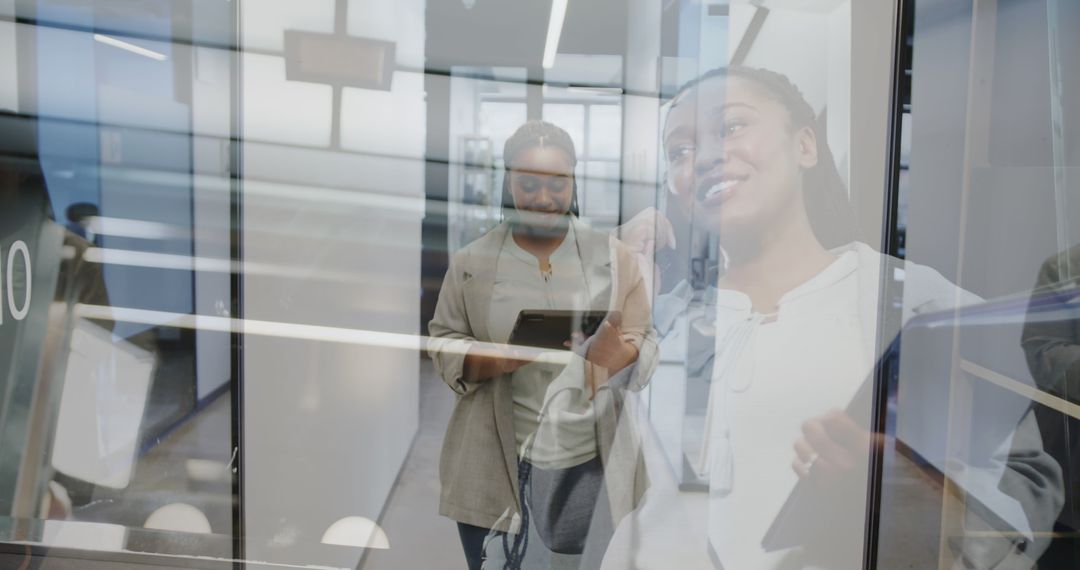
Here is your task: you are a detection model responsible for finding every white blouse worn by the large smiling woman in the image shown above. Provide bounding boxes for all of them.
[699,250,874,570]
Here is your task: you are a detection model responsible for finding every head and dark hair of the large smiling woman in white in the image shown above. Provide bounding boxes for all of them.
[663,67,858,260]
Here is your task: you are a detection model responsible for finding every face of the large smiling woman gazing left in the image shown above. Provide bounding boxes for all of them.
[664,77,818,238]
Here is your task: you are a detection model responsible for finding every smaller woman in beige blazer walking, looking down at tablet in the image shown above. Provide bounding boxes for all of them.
[429,121,654,570]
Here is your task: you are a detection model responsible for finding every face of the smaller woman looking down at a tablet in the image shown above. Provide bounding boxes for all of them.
[510,147,573,230]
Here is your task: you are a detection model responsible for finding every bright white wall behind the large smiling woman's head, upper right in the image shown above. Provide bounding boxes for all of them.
[731,0,894,247]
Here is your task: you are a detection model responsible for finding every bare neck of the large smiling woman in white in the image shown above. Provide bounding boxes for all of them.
[720,216,836,313]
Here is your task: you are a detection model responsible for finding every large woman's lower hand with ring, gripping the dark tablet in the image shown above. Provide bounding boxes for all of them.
[792,410,875,483]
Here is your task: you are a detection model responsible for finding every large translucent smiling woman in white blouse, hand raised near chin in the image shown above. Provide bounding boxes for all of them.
[605,67,1061,570]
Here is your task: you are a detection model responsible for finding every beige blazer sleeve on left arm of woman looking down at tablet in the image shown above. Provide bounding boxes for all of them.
[428,254,480,395]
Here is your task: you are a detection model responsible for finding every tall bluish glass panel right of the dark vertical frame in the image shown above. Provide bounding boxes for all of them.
[877,0,1080,568]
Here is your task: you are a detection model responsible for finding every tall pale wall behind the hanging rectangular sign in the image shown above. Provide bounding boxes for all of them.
[243,0,421,566]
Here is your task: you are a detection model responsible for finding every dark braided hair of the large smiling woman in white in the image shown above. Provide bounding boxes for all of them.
[669,66,860,248]
